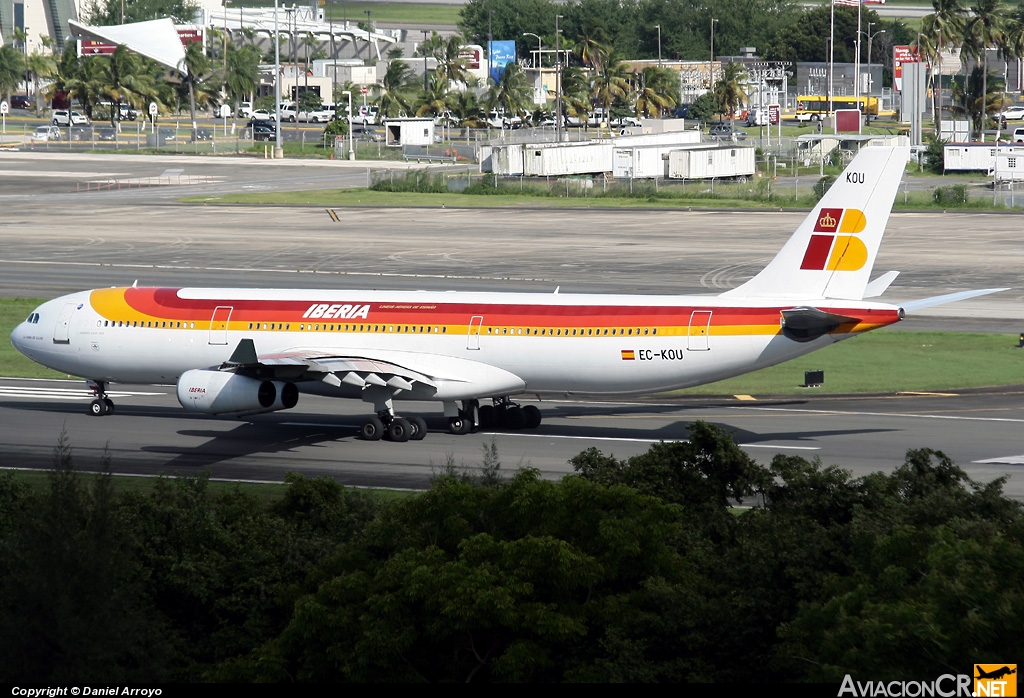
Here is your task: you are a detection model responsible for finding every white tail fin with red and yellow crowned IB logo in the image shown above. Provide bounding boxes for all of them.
[722,146,910,301]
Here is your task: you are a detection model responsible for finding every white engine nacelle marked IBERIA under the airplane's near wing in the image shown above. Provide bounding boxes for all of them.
[177,368,299,417]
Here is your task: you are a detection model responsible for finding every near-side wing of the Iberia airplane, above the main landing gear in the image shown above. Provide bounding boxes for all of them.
[220,339,526,400]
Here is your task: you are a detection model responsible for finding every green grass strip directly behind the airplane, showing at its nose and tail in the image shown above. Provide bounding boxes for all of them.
[0,296,1024,395]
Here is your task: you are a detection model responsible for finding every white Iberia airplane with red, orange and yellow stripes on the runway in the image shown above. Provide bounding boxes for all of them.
[11,147,1005,442]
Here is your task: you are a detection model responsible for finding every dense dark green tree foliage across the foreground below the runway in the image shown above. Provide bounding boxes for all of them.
[0,423,1024,683]
